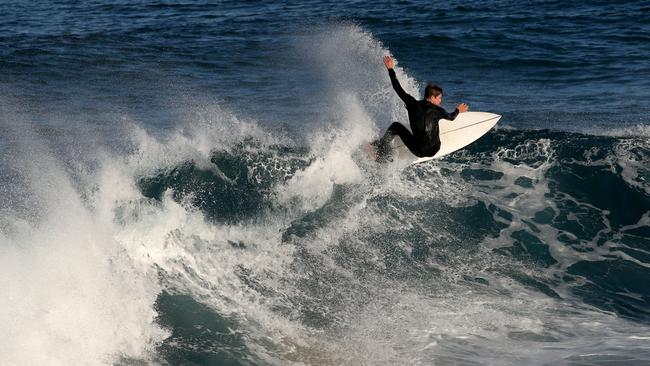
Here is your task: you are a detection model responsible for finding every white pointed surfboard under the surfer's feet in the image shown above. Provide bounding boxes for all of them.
[391,112,501,164]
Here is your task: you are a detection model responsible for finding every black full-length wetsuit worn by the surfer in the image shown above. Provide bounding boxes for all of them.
[374,69,459,159]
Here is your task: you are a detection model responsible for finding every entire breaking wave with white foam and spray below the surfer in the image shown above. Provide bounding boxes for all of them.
[0,4,650,365]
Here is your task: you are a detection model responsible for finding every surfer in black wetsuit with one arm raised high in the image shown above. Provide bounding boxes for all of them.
[368,56,469,161]
